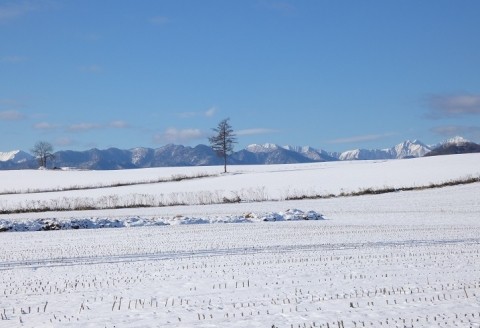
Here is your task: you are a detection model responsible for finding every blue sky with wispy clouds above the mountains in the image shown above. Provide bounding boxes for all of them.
[0,0,480,151]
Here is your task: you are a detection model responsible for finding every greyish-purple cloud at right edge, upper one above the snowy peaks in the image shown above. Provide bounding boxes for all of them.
[426,94,480,119]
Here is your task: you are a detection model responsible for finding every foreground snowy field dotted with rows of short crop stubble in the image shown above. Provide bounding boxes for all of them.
[0,221,480,327]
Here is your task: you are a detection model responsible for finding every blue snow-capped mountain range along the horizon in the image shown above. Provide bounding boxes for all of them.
[0,137,480,170]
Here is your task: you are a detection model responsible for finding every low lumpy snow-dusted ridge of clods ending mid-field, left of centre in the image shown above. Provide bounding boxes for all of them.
[0,209,325,232]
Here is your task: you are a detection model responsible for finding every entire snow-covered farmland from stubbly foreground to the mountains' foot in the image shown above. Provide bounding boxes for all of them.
[0,154,480,328]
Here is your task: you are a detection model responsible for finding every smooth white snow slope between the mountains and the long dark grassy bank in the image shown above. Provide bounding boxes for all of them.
[0,154,480,210]
